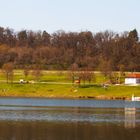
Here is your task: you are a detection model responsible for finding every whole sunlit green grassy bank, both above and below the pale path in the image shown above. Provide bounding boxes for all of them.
[0,70,140,99]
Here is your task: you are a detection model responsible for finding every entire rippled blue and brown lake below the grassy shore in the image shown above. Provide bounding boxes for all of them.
[0,98,140,140]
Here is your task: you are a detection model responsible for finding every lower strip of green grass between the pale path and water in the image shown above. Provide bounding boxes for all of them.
[0,83,140,99]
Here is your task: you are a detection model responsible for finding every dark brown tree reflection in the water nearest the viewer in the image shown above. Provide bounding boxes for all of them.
[0,121,140,140]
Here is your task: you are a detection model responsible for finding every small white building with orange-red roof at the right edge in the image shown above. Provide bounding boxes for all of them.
[125,74,140,85]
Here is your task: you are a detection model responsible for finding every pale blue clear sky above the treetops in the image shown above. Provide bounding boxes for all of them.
[0,0,140,33]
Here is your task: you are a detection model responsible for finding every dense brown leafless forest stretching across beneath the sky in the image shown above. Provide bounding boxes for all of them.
[0,27,140,72]
